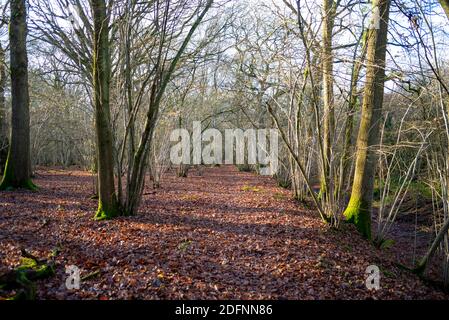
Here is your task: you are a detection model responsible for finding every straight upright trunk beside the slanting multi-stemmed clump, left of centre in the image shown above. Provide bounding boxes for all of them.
[91,0,119,220]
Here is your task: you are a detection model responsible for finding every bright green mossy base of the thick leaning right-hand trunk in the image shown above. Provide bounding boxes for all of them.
[343,197,371,240]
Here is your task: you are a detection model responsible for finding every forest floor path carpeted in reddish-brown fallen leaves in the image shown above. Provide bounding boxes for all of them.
[0,167,448,299]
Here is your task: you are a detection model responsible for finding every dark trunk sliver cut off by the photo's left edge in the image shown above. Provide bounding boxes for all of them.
[0,45,9,174]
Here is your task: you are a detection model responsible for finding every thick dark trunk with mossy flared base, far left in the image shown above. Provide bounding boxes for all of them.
[0,0,36,190]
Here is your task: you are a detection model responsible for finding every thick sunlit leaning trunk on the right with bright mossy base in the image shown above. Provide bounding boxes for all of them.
[344,0,390,239]
